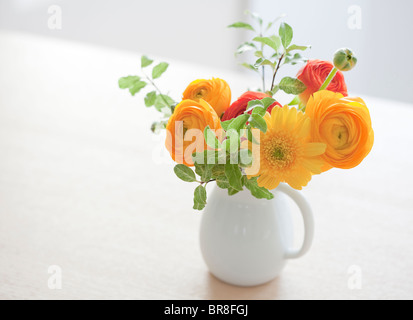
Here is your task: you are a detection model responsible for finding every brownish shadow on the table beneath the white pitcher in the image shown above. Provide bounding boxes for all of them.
[205,272,281,300]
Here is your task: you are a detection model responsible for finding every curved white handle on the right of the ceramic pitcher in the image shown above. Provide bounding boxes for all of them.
[277,183,314,259]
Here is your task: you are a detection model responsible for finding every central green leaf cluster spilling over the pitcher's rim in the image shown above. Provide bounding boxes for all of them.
[174,98,275,210]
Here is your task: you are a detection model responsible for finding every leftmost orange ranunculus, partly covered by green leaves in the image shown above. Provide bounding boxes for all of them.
[165,99,221,166]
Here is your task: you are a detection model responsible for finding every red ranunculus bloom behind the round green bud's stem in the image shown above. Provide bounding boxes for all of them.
[297,60,348,104]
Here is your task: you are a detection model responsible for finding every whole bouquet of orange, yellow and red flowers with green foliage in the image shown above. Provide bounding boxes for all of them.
[119,14,374,210]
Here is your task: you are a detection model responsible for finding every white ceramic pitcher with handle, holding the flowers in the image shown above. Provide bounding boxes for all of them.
[200,184,314,286]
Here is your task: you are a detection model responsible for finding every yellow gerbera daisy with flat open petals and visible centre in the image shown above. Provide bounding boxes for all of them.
[246,106,326,190]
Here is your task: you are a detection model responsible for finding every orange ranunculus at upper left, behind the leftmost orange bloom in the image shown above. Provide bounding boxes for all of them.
[183,78,231,117]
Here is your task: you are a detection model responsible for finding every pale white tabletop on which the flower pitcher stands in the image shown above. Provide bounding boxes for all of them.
[0,32,413,299]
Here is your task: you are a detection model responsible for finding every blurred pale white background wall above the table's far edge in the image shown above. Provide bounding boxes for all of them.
[0,0,413,102]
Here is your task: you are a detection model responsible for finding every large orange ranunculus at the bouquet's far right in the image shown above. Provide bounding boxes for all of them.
[305,90,374,171]
